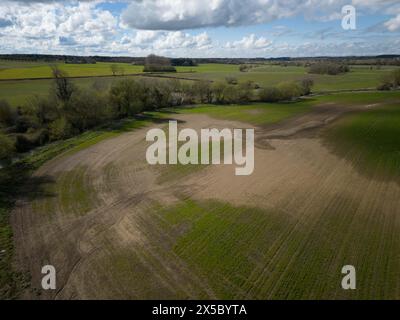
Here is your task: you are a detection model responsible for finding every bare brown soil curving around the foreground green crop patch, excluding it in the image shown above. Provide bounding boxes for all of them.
[12,105,400,299]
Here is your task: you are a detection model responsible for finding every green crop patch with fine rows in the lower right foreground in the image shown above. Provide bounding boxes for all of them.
[150,194,400,299]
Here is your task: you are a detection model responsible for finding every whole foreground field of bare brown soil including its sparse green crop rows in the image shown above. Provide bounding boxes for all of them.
[12,104,400,299]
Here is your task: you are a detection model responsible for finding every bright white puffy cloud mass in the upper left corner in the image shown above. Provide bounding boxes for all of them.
[0,2,118,52]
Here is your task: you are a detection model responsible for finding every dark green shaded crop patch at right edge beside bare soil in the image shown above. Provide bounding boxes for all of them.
[323,103,400,181]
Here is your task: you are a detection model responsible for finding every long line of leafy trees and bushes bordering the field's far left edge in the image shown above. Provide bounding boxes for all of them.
[0,66,313,162]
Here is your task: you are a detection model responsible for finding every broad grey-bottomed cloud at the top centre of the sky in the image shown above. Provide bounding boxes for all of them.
[122,0,296,30]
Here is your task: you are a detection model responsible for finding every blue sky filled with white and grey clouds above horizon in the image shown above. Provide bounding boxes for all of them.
[0,0,400,58]
